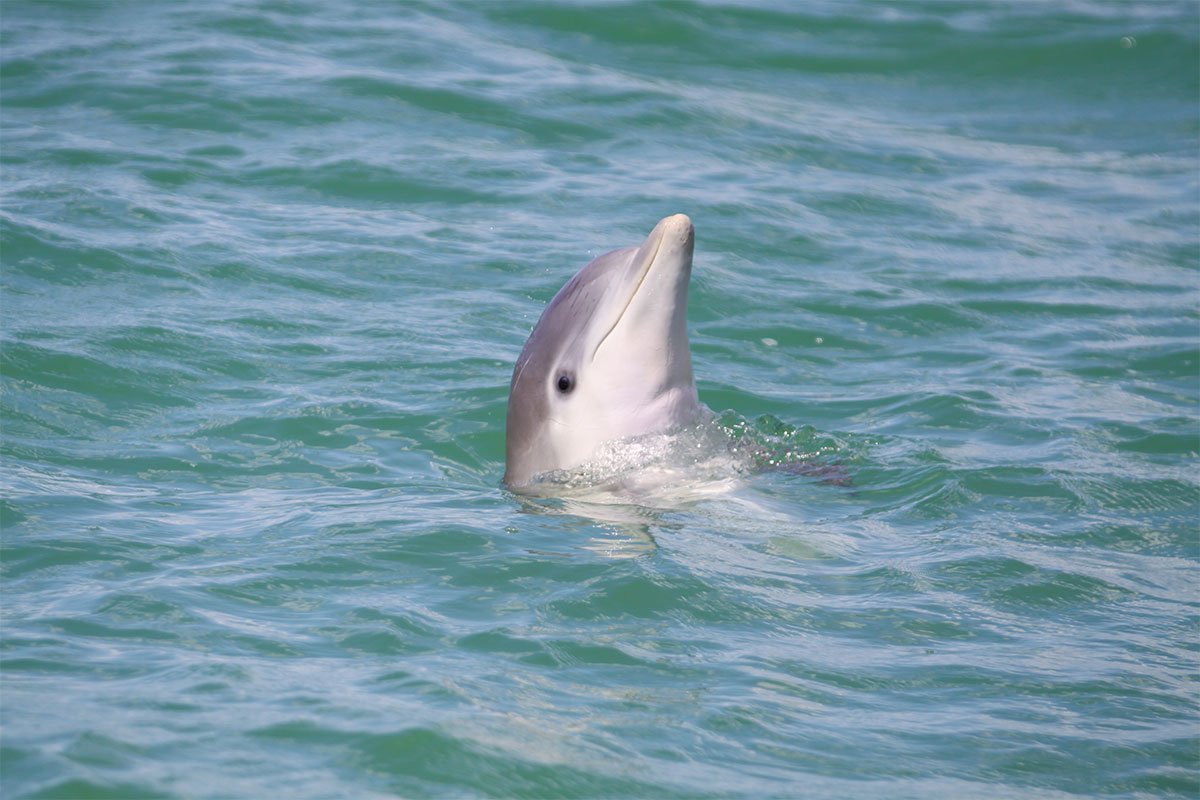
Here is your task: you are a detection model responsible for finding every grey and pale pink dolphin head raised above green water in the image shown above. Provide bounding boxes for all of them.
[504,213,700,487]
